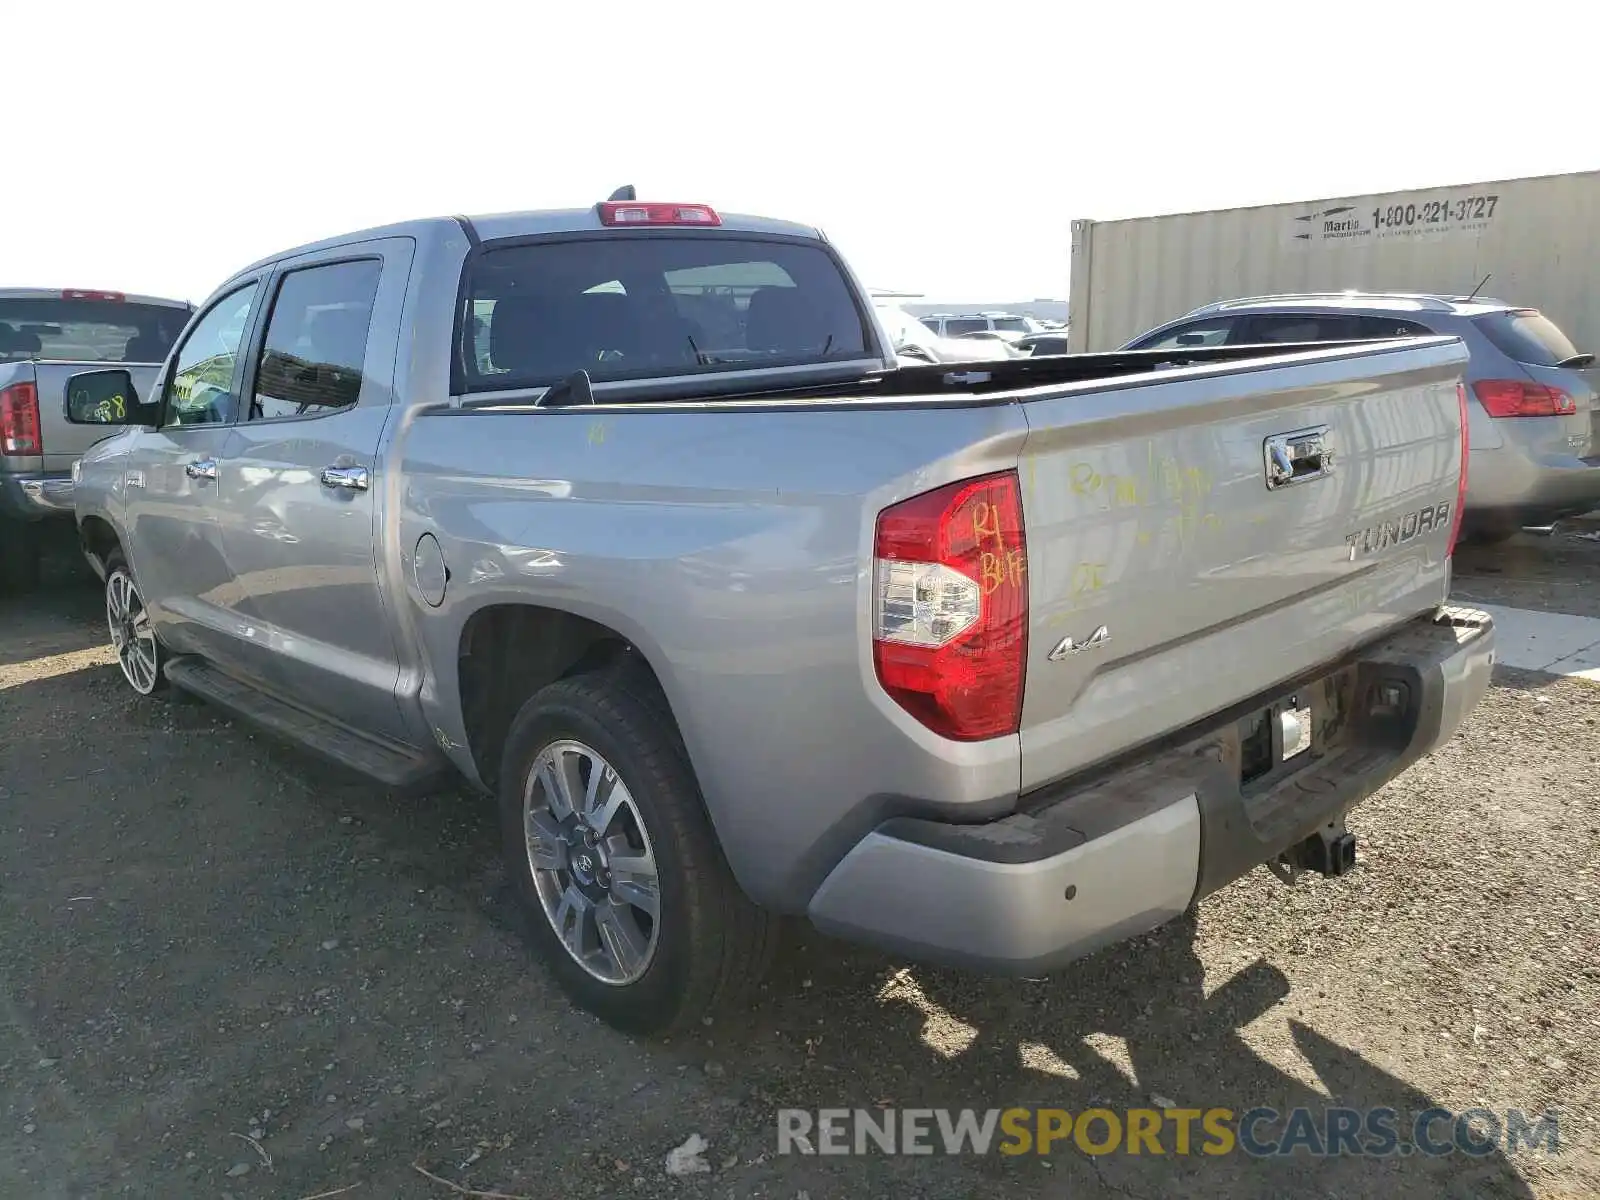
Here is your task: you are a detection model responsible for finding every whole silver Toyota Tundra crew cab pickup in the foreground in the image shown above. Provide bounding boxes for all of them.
[70,195,1494,1032]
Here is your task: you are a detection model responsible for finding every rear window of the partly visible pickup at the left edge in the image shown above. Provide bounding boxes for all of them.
[0,296,189,363]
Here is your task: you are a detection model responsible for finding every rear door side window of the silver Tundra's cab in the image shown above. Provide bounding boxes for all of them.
[250,259,384,421]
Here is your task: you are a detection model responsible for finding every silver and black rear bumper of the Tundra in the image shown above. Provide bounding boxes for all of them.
[808,608,1494,974]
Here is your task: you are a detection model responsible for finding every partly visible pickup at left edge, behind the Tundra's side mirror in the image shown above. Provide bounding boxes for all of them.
[0,288,192,594]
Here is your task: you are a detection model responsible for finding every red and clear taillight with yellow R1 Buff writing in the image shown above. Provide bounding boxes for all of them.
[872,470,1027,741]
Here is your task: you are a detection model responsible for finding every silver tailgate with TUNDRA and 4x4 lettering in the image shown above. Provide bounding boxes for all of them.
[1021,341,1467,790]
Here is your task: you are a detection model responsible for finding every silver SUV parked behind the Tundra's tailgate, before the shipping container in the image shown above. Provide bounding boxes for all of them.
[1122,291,1600,541]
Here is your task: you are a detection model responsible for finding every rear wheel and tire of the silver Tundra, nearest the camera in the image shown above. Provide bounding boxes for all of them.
[499,662,776,1035]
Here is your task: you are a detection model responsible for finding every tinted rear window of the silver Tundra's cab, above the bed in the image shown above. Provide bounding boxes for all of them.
[464,235,867,390]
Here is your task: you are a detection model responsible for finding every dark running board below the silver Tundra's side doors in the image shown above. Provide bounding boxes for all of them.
[166,654,446,790]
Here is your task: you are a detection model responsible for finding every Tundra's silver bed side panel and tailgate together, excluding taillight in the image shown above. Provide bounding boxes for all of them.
[403,338,1464,910]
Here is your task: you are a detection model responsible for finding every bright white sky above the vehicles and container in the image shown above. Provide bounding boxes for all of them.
[9,0,1600,301]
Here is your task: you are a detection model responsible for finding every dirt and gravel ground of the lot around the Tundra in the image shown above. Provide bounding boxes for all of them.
[0,536,1600,1200]
